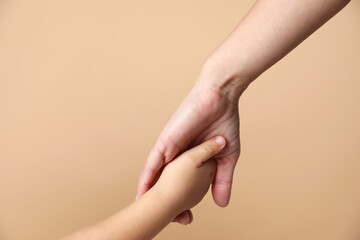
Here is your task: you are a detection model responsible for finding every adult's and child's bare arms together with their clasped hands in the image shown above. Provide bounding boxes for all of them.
[60,0,350,240]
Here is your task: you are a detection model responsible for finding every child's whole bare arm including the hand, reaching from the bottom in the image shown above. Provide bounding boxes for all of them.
[63,137,225,240]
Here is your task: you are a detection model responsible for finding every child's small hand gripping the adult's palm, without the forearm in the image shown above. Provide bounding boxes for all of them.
[153,136,225,218]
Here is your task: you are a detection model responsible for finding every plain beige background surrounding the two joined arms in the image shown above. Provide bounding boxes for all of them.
[0,0,360,240]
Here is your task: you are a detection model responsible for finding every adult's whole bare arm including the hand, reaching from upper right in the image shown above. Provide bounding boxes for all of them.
[137,0,350,223]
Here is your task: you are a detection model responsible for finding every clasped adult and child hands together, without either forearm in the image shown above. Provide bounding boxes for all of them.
[137,82,240,225]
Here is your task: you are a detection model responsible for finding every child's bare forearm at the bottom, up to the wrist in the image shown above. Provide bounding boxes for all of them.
[63,189,179,240]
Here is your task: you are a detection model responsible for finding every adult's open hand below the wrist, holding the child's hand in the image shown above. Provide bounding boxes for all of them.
[137,76,240,224]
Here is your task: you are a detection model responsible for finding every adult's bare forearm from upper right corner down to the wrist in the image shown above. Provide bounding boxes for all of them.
[198,0,350,99]
